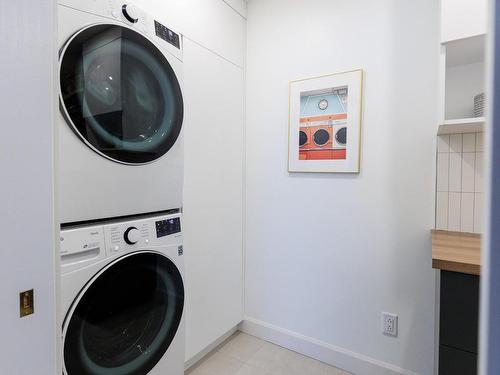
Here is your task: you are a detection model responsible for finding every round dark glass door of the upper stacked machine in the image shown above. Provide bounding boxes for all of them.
[60,24,183,164]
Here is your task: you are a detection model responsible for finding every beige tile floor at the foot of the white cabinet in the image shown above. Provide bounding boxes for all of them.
[187,332,349,375]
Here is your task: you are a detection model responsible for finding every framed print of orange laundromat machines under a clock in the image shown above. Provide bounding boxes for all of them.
[288,70,363,173]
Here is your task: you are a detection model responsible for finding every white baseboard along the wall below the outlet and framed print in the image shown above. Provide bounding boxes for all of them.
[239,317,420,375]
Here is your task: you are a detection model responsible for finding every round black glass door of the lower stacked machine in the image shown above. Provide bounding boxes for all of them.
[63,252,184,375]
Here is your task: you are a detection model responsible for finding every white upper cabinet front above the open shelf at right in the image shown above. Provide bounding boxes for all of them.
[441,0,488,43]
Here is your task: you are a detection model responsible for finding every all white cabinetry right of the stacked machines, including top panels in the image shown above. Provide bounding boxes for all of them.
[137,0,246,363]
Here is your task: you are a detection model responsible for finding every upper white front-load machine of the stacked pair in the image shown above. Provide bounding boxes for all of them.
[57,0,184,223]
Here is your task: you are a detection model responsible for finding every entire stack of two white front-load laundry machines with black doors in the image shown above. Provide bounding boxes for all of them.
[58,0,184,375]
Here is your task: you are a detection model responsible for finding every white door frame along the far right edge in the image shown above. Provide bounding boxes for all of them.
[479,0,500,375]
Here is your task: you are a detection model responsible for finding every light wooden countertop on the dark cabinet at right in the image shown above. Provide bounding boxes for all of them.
[432,230,481,275]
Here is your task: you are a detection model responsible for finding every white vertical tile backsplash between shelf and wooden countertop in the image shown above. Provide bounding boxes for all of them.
[436,133,484,233]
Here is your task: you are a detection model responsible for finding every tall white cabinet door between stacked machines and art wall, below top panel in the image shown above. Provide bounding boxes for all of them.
[184,40,244,361]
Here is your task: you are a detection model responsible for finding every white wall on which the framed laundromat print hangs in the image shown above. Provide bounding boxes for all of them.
[245,0,439,375]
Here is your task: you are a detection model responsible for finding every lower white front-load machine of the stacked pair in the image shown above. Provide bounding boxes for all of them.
[61,214,185,375]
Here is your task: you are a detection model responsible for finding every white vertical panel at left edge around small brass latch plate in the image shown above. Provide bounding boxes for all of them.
[0,0,61,375]
